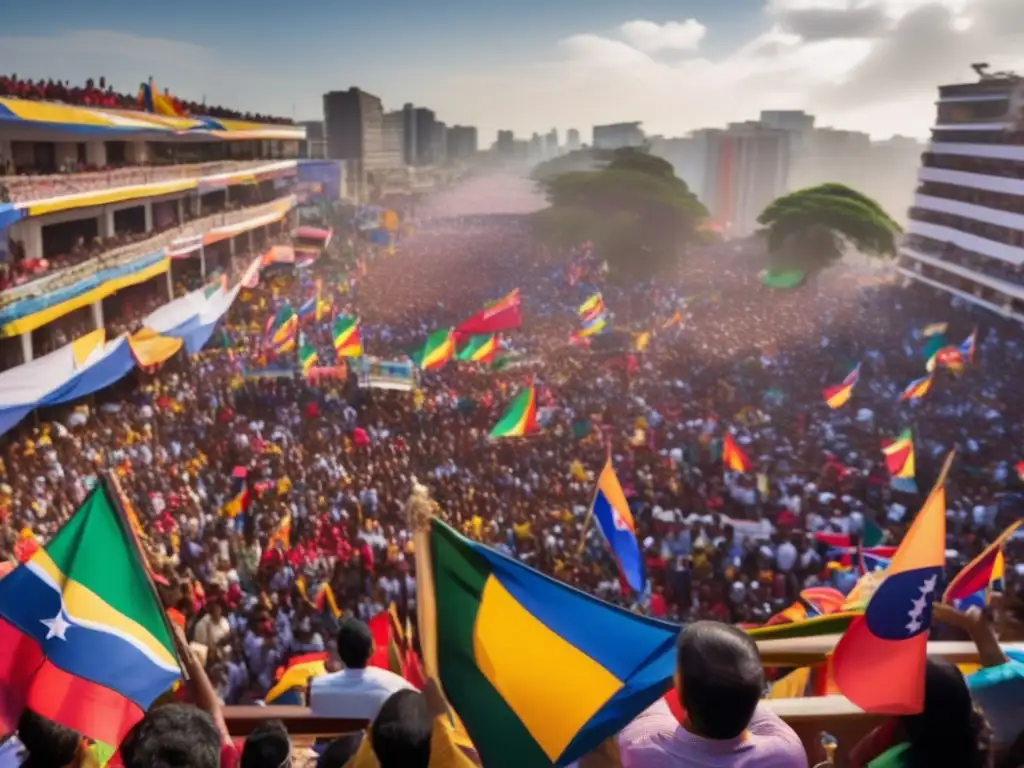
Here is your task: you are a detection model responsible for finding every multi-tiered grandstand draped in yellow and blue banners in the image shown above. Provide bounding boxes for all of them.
[0,90,305,370]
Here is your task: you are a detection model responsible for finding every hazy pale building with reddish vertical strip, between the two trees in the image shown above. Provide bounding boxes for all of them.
[694,121,790,238]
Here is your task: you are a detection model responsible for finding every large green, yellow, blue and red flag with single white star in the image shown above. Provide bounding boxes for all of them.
[0,481,181,744]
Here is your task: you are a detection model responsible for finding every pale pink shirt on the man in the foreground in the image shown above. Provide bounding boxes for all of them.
[618,699,807,768]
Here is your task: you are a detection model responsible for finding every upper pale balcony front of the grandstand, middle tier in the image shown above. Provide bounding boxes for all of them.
[0,160,295,206]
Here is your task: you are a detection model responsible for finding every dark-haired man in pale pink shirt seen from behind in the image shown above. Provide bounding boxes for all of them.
[617,621,807,768]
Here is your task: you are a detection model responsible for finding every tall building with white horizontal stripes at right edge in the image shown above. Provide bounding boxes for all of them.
[899,66,1024,323]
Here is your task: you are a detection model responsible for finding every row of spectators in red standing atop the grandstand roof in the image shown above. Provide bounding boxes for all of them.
[0,74,294,125]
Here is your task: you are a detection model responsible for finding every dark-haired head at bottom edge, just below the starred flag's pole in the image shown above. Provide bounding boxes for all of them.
[121,705,221,768]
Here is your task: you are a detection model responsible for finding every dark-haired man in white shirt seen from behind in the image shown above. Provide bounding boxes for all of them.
[309,617,413,720]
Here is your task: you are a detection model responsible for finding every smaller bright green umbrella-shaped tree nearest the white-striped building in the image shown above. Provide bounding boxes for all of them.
[758,184,901,274]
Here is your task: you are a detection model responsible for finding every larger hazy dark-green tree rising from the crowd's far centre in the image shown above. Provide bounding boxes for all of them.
[535,150,708,279]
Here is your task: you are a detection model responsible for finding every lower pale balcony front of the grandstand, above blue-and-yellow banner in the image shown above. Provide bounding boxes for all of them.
[0,198,294,307]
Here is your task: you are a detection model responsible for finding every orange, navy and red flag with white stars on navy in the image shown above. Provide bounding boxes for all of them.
[833,456,952,715]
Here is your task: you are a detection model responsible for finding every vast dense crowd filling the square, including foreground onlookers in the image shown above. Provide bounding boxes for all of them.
[0,205,1024,768]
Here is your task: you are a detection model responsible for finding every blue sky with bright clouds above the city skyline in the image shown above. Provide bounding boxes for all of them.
[0,0,1024,146]
